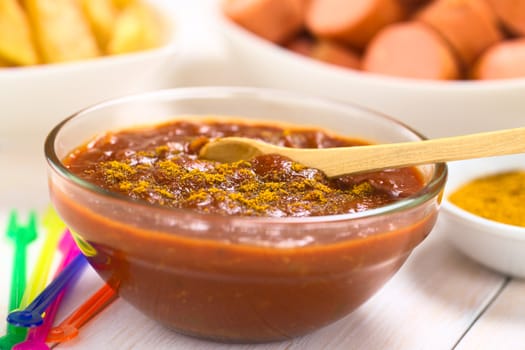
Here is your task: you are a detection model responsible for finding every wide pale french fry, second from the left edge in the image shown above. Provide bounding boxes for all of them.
[23,0,100,63]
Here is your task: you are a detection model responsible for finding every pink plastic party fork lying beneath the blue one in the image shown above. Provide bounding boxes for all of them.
[12,230,80,350]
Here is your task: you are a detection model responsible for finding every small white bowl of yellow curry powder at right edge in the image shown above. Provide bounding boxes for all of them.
[437,154,525,278]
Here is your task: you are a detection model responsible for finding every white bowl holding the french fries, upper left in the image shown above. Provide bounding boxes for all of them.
[0,0,180,150]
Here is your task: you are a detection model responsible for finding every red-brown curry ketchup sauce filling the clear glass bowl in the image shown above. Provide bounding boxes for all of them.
[51,121,437,342]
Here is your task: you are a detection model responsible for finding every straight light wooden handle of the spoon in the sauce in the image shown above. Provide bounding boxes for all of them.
[298,128,525,176]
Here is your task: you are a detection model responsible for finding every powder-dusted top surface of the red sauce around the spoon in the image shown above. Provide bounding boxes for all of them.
[64,121,423,217]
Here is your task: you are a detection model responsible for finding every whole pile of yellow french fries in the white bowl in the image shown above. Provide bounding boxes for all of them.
[0,0,164,67]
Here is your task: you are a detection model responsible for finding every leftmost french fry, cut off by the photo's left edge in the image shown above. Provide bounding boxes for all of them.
[0,0,38,65]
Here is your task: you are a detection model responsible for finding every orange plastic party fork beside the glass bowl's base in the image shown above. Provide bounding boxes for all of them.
[47,284,118,343]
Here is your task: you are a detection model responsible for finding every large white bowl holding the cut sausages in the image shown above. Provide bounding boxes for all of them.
[215,1,525,137]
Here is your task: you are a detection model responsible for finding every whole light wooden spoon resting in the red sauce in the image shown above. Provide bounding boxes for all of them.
[200,128,525,176]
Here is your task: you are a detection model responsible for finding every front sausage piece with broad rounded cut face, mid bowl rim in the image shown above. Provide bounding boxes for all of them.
[362,21,460,80]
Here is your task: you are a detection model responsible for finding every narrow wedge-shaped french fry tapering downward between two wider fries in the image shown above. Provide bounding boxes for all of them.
[82,0,118,51]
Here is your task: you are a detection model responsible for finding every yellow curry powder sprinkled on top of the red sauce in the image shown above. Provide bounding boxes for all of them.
[100,153,374,215]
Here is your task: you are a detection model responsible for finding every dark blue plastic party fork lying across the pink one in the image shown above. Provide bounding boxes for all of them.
[7,254,87,327]
